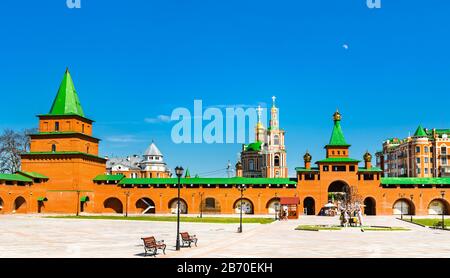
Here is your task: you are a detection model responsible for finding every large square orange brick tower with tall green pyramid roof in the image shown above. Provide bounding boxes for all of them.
[22,69,106,192]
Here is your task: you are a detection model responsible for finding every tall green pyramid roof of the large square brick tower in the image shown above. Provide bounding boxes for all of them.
[48,69,84,117]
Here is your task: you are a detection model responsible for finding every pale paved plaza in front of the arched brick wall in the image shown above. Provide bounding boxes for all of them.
[0,215,450,259]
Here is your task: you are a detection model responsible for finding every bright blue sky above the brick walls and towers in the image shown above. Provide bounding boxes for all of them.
[0,0,450,175]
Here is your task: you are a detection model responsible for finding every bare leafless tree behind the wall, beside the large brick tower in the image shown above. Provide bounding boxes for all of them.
[0,129,36,174]
